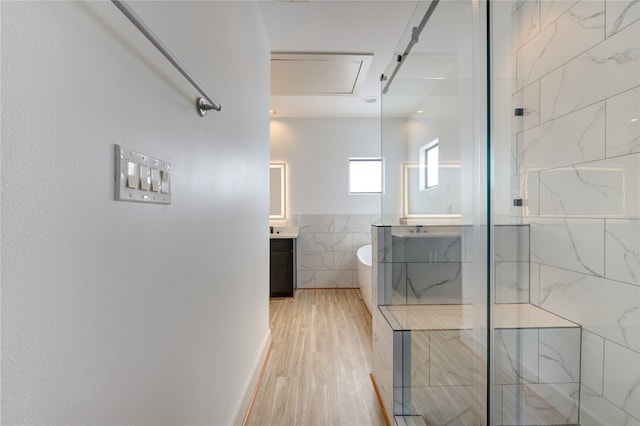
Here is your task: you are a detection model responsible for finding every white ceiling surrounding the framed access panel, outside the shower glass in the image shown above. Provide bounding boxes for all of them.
[260,0,417,117]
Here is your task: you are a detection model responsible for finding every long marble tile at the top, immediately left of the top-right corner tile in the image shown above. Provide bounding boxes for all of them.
[517,0,604,86]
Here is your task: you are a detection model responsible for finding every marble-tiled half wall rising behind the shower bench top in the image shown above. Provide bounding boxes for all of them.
[378,225,530,305]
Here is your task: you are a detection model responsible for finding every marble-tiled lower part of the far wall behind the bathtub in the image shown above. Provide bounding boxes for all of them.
[297,214,376,288]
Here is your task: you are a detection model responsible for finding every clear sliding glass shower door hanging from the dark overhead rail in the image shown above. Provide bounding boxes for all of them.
[373,1,493,425]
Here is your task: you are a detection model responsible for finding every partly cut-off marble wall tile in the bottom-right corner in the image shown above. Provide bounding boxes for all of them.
[580,386,640,426]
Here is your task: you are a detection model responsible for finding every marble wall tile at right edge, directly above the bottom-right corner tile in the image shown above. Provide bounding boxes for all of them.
[603,341,640,418]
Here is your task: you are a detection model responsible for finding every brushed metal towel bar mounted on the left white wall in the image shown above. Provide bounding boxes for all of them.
[111,0,222,117]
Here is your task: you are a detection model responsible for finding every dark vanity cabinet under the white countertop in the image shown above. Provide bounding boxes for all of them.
[269,238,296,297]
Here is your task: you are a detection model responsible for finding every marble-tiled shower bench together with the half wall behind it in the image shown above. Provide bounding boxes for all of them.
[372,225,581,425]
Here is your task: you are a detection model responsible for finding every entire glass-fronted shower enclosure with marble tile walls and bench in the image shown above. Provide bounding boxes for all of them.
[372,0,640,425]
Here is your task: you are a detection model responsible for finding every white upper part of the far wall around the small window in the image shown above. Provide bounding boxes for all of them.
[271,118,380,222]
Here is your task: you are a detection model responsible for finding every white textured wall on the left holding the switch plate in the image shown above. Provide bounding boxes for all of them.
[2,2,269,425]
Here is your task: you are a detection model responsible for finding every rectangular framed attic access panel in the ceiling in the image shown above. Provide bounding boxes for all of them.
[271,53,373,96]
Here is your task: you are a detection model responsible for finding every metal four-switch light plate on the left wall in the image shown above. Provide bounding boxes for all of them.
[115,144,171,204]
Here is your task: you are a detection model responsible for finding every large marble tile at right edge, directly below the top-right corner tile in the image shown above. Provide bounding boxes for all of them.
[540,22,640,121]
